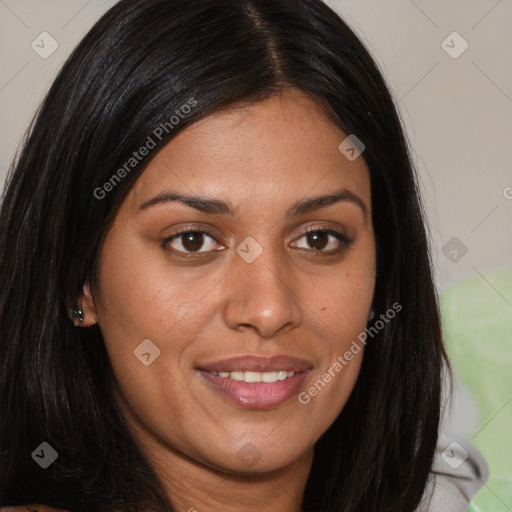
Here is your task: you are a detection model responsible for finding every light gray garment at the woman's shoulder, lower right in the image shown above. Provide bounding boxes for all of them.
[417,432,489,512]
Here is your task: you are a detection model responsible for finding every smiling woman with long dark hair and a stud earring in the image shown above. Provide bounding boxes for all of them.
[0,0,484,512]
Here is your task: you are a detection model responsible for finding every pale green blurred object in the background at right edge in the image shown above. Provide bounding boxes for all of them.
[440,268,512,512]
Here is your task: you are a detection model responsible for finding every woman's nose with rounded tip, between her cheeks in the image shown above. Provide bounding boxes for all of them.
[223,249,303,338]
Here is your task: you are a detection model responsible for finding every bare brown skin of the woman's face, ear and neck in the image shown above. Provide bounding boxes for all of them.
[80,89,375,512]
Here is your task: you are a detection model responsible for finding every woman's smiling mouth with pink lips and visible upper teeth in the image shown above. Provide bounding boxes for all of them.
[197,356,312,409]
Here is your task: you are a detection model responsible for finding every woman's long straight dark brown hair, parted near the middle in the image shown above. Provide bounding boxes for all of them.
[0,0,445,512]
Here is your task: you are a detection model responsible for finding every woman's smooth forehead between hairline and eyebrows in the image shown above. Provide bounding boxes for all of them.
[127,90,370,213]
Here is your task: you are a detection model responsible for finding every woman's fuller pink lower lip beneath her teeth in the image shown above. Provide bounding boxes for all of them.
[200,370,309,409]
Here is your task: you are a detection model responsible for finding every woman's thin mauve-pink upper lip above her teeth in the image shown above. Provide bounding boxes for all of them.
[198,355,313,373]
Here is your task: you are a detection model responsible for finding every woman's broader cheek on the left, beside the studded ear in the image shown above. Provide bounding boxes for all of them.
[94,244,234,400]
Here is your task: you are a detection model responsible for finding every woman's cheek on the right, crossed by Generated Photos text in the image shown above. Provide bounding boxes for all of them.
[290,266,375,426]
